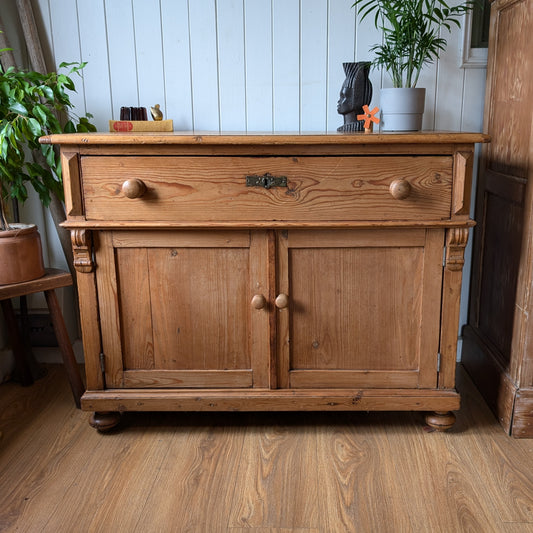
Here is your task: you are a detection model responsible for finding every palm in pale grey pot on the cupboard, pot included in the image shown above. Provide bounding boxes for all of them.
[352,0,475,131]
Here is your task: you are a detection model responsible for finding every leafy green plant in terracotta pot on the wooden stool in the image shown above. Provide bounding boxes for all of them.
[0,56,95,284]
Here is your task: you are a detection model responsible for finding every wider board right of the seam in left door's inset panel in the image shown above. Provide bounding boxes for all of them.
[148,248,250,370]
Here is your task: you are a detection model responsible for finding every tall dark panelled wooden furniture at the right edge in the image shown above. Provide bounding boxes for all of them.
[462,0,533,437]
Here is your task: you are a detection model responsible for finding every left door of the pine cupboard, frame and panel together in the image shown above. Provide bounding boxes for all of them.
[96,231,270,388]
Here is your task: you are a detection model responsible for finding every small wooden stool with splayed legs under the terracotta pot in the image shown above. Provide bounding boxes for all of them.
[0,268,85,409]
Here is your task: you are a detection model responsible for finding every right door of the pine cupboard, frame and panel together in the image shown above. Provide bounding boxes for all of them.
[278,229,444,388]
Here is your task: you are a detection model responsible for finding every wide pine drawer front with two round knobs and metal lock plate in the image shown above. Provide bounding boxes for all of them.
[81,156,452,223]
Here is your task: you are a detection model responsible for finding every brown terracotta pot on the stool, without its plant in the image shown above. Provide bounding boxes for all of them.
[0,224,45,285]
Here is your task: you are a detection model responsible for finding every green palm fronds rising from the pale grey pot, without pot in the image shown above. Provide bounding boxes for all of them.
[352,0,475,88]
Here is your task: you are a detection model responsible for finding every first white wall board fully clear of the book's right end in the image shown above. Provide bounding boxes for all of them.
[189,0,220,131]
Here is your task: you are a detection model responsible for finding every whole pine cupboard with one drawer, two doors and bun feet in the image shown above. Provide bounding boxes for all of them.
[42,132,487,431]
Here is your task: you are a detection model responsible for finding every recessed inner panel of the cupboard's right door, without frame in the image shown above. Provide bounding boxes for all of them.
[289,248,423,370]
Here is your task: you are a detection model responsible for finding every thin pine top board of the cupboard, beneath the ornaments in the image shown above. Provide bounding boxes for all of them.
[40,131,490,145]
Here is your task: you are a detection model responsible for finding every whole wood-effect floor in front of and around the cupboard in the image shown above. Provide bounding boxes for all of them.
[0,366,533,533]
